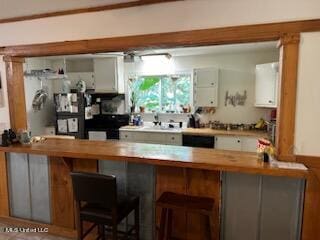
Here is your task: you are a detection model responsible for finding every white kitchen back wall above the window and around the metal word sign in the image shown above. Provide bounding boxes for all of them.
[125,49,279,124]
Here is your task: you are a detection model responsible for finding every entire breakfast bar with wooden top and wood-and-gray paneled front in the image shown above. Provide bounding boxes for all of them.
[0,139,308,240]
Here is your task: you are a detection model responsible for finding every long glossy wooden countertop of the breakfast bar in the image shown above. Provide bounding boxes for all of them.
[0,139,308,178]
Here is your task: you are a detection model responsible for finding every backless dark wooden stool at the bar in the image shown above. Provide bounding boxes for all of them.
[156,192,214,240]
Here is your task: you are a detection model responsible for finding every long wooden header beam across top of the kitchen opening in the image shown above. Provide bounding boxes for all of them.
[0,19,320,57]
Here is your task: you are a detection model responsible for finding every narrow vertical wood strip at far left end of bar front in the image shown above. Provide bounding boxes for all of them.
[0,152,10,217]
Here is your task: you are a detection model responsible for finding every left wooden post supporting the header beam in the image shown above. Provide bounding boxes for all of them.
[3,56,27,131]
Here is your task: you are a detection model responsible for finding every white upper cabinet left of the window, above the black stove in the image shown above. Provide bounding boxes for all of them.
[93,57,124,93]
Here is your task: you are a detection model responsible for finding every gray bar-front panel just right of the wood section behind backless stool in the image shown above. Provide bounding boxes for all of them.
[221,173,260,240]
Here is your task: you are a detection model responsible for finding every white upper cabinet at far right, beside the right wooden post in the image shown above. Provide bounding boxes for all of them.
[255,62,279,108]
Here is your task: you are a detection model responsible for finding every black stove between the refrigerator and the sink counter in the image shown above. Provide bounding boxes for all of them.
[85,114,130,139]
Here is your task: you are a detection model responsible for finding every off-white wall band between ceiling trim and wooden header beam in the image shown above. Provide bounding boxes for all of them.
[0,0,320,46]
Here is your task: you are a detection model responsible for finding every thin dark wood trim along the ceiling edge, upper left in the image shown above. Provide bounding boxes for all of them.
[0,0,184,24]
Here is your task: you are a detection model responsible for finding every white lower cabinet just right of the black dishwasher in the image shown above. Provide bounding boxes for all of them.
[214,136,258,152]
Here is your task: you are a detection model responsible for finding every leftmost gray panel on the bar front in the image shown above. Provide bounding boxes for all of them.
[7,153,31,219]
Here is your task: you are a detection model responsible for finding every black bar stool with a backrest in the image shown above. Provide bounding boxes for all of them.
[70,172,139,240]
